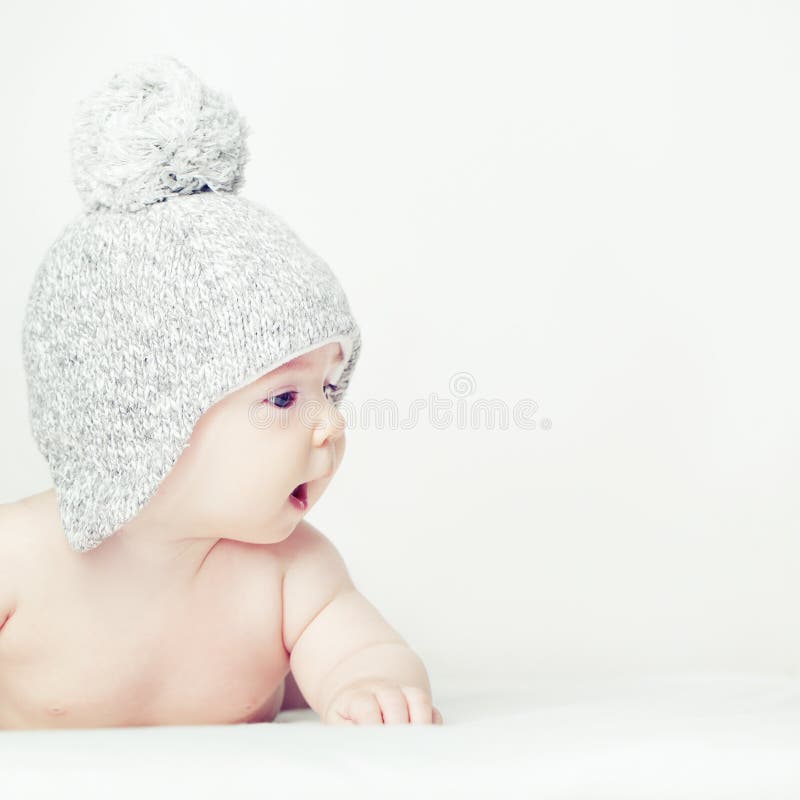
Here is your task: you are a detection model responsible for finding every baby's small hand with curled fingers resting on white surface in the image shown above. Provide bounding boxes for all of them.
[323,680,444,725]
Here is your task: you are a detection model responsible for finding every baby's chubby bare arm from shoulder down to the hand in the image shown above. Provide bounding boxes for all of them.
[283,521,441,723]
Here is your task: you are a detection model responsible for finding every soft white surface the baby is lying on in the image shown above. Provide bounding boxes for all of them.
[0,674,800,800]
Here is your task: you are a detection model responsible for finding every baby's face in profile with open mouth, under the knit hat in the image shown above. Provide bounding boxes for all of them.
[129,342,345,543]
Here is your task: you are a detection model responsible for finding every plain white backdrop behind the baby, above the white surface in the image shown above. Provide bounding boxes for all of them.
[0,0,800,692]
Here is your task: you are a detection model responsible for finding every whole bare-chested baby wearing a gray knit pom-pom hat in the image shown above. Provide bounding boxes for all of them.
[0,57,443,729]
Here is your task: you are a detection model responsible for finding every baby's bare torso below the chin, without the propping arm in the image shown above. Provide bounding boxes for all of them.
[0,489,289,729]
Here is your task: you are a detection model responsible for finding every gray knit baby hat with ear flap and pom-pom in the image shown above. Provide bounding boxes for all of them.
[22,55,361,552]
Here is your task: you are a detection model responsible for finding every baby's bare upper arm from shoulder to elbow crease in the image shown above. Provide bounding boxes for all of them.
[280,520,355,653]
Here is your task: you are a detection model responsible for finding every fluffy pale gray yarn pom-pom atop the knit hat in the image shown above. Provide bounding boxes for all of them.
[70,55,249,211]
